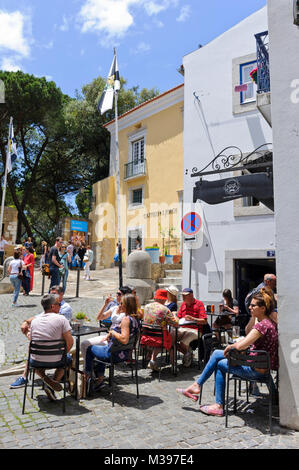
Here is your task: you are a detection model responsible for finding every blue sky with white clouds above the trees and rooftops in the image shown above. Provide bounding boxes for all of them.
[0,0,266,97]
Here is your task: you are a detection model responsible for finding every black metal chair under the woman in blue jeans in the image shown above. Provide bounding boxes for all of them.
[225,349,273,435]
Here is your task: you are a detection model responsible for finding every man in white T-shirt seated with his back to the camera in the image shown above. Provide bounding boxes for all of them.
[10,294,73,400]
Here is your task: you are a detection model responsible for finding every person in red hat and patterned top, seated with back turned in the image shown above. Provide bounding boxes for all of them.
[140,289,178,371]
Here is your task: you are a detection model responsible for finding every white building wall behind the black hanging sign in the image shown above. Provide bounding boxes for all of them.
[183,8,275,302]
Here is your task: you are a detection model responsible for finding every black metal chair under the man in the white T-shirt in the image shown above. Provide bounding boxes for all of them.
[22,339,68,414]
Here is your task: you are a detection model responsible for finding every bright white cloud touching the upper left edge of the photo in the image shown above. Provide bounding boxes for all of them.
[0,10,32,57]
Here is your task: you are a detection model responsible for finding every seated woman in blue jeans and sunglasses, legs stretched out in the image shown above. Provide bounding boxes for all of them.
[177,289,278,416]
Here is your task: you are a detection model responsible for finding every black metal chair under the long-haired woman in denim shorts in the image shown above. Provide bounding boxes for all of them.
[89,332,139,407]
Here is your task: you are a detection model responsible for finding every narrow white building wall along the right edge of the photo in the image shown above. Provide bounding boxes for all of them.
[268,0,299,429]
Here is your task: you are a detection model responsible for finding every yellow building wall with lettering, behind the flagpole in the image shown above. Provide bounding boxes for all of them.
[90,96,184,267]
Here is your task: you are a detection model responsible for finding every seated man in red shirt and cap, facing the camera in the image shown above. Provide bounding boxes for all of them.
[177,288,207,367]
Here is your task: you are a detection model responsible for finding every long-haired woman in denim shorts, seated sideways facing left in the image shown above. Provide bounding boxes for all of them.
[85,294,139,391]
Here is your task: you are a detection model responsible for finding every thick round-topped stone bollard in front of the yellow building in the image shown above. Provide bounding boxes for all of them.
[125,250,155,305]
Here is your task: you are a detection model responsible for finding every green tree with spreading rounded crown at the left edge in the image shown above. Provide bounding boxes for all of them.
[0,71,69,240]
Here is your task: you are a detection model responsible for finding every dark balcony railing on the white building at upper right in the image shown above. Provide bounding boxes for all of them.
[255,31,270,93]
